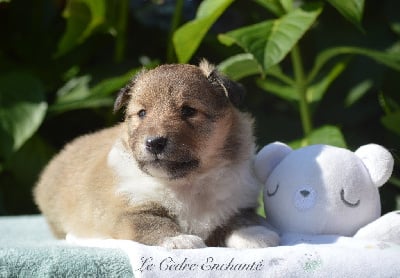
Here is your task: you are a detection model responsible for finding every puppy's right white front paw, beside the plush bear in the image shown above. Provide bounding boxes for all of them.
[225,226,279,248]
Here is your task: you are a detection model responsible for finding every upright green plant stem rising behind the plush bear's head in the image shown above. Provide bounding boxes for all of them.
[290,45,313,137]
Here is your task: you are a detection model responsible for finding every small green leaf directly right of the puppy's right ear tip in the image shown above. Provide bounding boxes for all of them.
[218,53,262,80]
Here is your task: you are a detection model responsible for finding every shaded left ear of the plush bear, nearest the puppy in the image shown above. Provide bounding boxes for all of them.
[254,142,292,183]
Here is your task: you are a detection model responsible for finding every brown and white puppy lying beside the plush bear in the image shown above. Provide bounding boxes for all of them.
[34,60,279,248]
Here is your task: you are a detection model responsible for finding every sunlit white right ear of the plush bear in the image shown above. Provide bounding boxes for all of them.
[355,144,394,187]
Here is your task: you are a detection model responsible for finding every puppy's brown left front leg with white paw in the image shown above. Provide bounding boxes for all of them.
[114,205,206,249]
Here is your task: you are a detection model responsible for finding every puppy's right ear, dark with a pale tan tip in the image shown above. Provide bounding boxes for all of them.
[199,60,246,107]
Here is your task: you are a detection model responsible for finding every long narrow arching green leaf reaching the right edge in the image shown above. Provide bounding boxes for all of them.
[307,46,400,82]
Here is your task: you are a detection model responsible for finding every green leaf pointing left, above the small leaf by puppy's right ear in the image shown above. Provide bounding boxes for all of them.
[218,20,274,66]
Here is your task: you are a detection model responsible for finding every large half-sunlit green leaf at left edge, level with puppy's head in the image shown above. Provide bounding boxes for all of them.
[0,72,47,158]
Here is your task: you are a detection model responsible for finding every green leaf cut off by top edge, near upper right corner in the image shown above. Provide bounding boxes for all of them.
[326,0,364,30]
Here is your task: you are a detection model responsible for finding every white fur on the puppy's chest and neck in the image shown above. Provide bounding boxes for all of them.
[108,141,259,238]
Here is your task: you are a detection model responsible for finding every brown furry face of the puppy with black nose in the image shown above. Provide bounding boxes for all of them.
[117,62,245,179]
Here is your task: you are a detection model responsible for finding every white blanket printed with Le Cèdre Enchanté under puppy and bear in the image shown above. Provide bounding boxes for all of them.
[67,234,400,278]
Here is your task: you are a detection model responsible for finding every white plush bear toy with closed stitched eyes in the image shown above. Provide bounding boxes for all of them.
[255,142,400,242]
